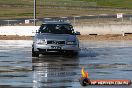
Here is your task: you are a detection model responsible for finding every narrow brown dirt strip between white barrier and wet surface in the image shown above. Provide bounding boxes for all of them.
[0,34,132,40]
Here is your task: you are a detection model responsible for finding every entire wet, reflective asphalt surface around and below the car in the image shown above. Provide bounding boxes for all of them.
[0,40,132,88]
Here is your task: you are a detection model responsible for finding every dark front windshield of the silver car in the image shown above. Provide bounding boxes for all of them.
[39,24,74,35]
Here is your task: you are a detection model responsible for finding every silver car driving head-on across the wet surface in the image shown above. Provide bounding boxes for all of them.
[32,22,80,57]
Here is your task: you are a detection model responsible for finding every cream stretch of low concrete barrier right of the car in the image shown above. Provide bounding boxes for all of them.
[75,24,132,35]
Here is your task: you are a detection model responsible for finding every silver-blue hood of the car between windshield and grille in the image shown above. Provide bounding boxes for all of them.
[37,33,76,41]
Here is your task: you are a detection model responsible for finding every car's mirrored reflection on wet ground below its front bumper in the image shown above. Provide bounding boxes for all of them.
[32,55,78,88]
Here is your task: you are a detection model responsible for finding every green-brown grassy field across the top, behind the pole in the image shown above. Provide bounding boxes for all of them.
[0,0,132,19]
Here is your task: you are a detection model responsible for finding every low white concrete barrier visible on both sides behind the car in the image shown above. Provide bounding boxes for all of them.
[0,25,132,36]
